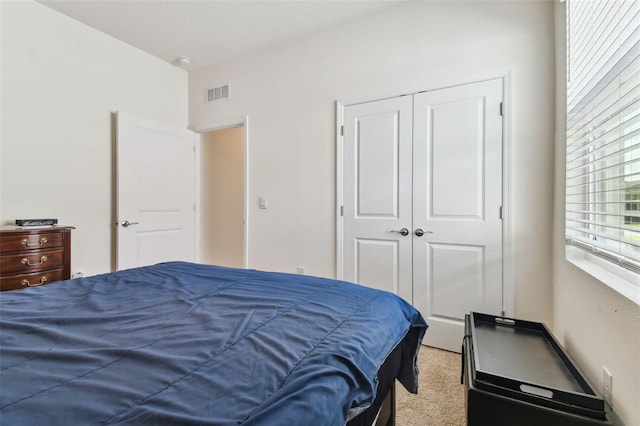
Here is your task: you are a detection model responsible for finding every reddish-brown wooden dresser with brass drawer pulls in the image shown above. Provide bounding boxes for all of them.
[0,226,74,291]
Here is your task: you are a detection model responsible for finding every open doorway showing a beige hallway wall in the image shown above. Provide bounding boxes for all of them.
[196,123,248,268]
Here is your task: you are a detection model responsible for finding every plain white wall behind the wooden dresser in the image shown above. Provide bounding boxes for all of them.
[0,1,188,274]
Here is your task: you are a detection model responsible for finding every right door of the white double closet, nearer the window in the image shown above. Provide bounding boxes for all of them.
[413,79,502,351]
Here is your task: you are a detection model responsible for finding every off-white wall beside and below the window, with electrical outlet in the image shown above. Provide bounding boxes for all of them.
[553,2,640,426]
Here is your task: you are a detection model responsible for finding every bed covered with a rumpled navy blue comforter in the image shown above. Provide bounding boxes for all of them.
[0,262,427,425]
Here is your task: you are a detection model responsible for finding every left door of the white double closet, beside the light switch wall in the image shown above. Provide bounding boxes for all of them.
[343,96,412,302]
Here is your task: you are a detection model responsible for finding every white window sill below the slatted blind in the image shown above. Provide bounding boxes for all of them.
[565,245,640,305]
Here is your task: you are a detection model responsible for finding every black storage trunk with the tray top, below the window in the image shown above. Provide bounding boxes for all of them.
[461,312,622,426]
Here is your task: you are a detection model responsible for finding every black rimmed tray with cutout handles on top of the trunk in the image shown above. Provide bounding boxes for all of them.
[465,312,606,419]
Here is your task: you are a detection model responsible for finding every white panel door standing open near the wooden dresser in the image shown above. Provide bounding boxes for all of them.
[116,113,195,270]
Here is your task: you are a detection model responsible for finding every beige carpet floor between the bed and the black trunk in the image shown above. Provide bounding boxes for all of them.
[396,346,465,426]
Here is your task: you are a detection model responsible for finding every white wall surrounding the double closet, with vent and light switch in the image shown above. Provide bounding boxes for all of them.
[189,1,554,324]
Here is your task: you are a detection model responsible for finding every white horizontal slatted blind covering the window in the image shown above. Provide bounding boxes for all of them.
[565,0,640,272]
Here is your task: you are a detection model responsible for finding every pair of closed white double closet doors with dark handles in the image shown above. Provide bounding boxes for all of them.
[342,79,503,352]
